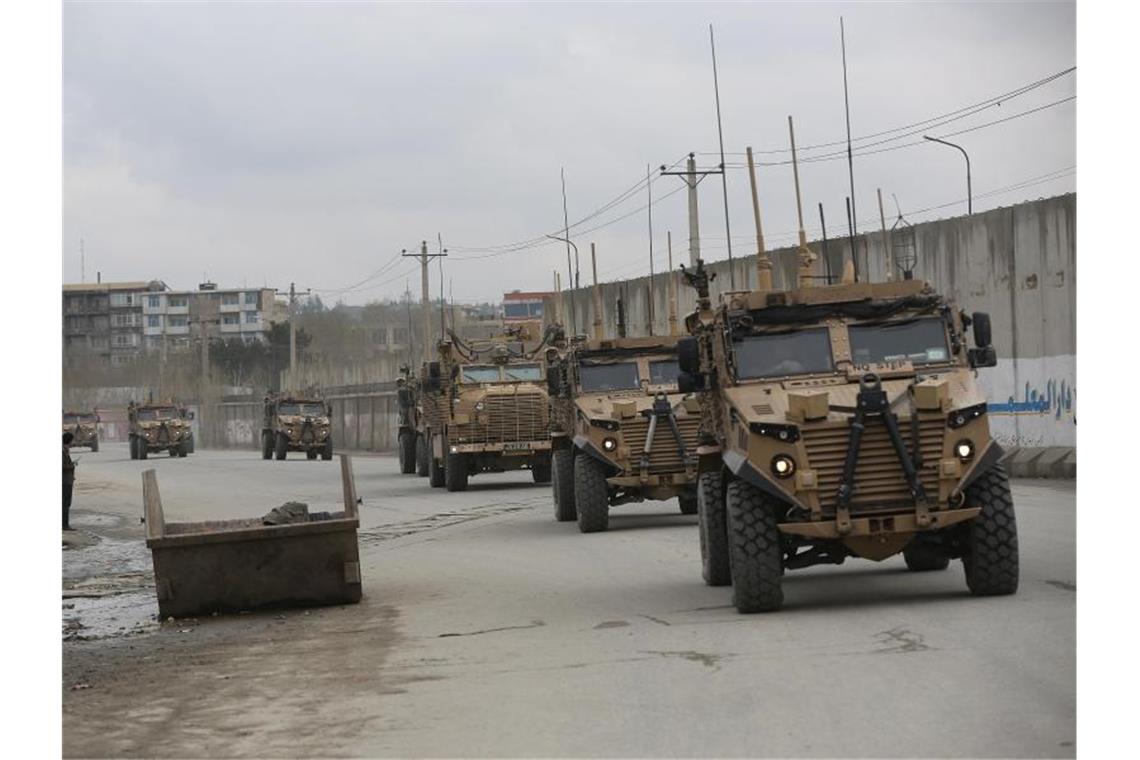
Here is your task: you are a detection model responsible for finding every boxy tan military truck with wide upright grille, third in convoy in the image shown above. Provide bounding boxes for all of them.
[420,333,551,491]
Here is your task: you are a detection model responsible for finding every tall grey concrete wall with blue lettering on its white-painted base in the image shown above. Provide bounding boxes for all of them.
[561,194,1076,447]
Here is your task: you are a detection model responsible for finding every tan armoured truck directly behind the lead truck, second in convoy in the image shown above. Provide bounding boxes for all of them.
[547,337,700,533]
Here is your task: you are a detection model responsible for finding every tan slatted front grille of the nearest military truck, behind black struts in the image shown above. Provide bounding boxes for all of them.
[803,415,946,512]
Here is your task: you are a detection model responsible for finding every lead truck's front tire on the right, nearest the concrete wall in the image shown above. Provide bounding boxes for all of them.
[962,465,1020,596]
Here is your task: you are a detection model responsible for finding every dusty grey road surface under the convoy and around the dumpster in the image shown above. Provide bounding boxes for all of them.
[63,446,1076,757]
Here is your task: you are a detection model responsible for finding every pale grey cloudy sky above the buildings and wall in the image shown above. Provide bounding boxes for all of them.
[62,2,1076,303]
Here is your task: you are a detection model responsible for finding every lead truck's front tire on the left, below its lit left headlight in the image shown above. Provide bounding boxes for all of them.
[725,479,783,613]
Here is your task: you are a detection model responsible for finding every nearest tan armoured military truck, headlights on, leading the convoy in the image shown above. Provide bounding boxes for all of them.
[678,258,1018,612]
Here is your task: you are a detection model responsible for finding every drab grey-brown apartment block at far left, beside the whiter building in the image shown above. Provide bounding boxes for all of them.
[63,280,166,363]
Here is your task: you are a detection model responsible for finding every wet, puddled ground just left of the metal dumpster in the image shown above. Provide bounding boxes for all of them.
[63,513,158,641]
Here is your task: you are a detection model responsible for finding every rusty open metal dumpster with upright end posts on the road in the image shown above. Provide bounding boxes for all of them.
[143,455,360,618]
